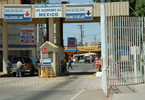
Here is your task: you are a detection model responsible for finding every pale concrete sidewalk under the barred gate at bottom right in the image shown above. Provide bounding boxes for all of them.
[108,84,145,100]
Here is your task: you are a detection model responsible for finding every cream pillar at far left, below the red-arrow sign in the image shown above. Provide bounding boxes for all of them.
[2,22,8,73]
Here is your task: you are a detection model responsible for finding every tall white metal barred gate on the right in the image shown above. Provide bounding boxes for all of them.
[106,17,144,86]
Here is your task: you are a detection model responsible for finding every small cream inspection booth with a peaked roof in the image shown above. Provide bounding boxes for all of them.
[40,41,64,77]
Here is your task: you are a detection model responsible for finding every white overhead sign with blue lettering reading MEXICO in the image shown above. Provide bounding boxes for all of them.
[35,3,62,18]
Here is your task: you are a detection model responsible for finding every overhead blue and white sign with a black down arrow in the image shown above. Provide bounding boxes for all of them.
[65,6,93,21]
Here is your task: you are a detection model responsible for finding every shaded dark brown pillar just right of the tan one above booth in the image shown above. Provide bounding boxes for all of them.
[56,18,60,45]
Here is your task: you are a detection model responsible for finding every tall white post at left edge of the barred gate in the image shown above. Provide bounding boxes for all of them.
[101,5,108,96]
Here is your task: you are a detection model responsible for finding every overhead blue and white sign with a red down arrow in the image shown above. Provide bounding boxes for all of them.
[4,6,31,21]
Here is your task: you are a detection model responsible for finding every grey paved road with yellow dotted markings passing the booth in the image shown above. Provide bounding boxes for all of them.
[0,64,106,100]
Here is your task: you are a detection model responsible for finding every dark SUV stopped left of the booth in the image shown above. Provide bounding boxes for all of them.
[11,56,40,76]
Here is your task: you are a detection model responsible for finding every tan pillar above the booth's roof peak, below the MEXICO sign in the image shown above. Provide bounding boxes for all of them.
[49,18,54,43]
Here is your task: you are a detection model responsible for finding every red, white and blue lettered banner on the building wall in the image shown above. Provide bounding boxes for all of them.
[20,28,34,44]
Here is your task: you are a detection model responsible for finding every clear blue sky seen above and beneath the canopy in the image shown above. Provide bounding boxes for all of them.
[50,0,101,46]
